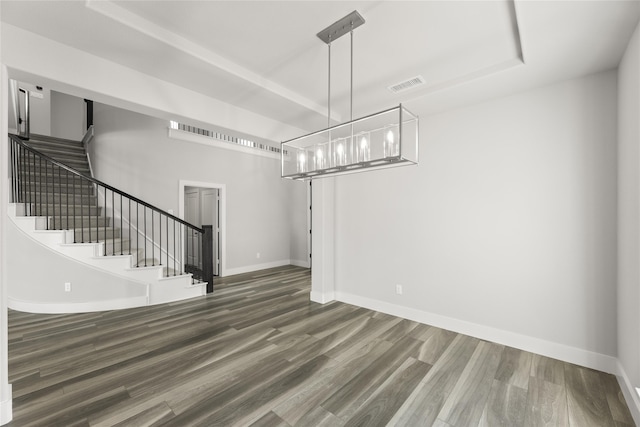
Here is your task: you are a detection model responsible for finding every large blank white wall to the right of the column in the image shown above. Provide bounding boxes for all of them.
[334,71,616,371]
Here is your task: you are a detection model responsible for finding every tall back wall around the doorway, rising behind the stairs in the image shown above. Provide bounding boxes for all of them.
[90,104,306,275]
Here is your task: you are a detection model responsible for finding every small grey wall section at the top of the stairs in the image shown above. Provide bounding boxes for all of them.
[51,90,86,141]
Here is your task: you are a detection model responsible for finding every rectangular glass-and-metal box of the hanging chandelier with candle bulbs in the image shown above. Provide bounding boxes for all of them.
[281,104,419,180]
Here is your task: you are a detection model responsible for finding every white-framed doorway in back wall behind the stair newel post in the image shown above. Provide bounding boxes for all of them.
[180,181,225,277]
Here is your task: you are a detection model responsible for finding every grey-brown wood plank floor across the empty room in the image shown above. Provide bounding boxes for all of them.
[9,267,634,427]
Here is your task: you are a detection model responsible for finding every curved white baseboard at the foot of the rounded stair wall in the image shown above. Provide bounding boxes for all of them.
[7,296,149,314]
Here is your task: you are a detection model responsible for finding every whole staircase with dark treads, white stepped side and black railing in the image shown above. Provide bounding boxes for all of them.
[10,135,212,308]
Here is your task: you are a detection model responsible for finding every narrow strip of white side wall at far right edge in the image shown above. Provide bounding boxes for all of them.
[618,16,640,412]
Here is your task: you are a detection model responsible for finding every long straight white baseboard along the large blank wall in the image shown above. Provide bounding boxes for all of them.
[336,292,618,374]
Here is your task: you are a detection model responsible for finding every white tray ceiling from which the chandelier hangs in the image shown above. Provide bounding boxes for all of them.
[0,0,640,131]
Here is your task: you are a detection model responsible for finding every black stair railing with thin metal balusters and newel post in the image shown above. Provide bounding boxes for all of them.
[9,135,213,292]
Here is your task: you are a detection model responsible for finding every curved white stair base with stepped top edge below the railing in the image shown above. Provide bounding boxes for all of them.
[7,204,206,313]
